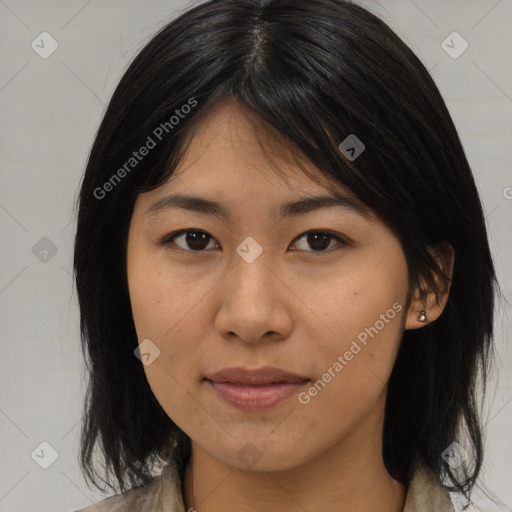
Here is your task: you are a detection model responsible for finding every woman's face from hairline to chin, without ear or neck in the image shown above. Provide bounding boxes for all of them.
[127,102,414,470]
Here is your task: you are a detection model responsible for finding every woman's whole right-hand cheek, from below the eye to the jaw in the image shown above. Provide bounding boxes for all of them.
[298,247,408,404]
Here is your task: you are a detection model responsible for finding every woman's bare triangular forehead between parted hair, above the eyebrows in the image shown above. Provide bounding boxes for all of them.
[160,99,342,195]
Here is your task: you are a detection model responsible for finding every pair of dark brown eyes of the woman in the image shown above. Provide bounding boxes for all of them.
[160,229,348,252]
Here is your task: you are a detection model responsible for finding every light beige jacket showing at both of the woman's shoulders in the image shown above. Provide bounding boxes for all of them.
[75,457,455,512]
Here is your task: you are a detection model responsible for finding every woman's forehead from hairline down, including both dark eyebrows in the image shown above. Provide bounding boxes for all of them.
[135,100,372,226]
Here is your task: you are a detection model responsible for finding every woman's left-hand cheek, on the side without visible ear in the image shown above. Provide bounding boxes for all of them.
[127,245,207,386]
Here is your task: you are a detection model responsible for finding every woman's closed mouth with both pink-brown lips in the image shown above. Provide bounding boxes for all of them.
[204,367,311,411]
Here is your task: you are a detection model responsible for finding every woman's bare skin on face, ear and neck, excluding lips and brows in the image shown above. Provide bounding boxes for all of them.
[127,101,453,512]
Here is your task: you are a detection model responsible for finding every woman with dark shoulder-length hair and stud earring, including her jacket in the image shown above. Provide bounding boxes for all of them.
[74,0,497,512]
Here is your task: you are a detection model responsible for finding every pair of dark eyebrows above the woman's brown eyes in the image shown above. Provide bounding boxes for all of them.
[145,193,371,220]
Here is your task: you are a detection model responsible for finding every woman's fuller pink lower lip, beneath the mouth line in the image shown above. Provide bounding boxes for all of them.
[207,380,309,411]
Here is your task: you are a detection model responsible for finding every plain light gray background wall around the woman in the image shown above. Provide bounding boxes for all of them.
[0,0,512,512]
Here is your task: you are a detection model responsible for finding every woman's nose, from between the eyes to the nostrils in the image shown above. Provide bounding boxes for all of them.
[215,248,297,343]
